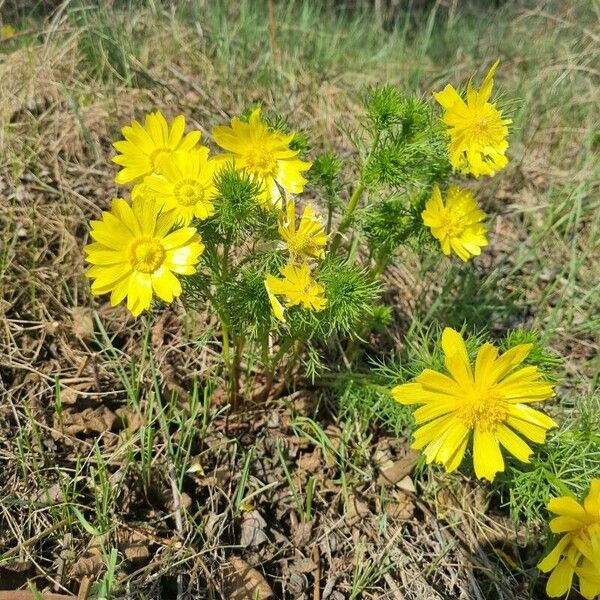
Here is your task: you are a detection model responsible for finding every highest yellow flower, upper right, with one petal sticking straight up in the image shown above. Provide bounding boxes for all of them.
[433,60,512,177]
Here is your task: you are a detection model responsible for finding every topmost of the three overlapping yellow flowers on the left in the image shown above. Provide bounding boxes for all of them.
[112,111,200,184]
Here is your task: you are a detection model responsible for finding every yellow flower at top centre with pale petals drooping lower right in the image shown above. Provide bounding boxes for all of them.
[212,108,311,206]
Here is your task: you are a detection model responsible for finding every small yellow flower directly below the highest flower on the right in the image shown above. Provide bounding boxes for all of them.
[421,185,488,262]
